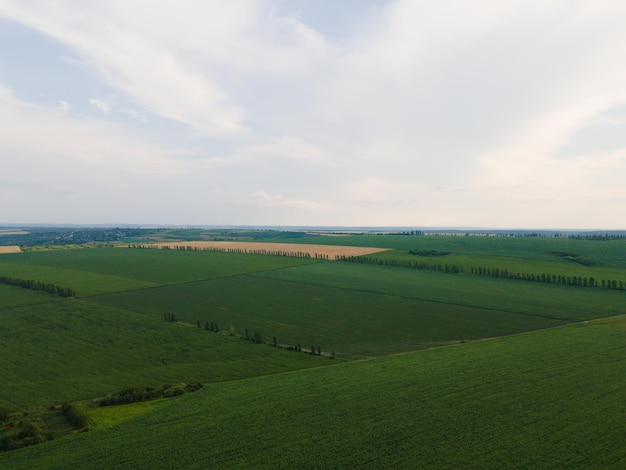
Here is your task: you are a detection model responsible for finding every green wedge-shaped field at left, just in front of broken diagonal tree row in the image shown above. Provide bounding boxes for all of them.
[0,298,320,409]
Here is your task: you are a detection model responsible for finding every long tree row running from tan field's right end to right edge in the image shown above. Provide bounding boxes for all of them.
[337,256,624,290]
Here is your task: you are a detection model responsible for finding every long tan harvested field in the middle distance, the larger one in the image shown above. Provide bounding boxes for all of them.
[146,242,389,260]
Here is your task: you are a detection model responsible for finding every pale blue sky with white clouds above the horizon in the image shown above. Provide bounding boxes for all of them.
[0,0,626,230]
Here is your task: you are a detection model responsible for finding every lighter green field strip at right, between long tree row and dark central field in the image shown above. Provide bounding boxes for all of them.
[258,262,626,321]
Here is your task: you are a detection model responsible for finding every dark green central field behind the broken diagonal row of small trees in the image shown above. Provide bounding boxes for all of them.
[94,276,565,356]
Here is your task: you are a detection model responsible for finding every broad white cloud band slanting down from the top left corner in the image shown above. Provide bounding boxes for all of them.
[4,1,249,135]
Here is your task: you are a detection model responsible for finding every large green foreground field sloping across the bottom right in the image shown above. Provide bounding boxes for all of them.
[0,318,626,469]
